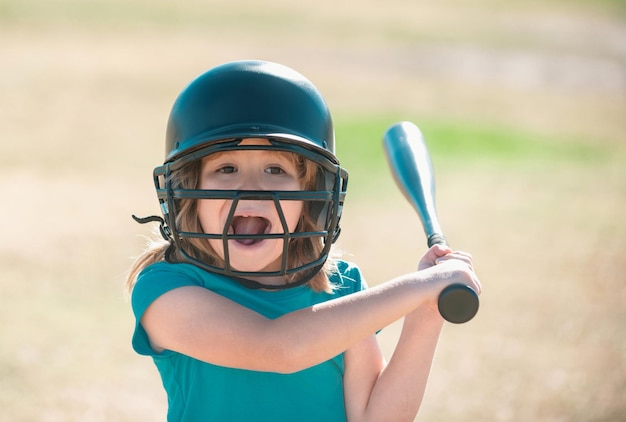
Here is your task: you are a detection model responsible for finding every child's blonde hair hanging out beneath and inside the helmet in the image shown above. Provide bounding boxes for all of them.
[125,152,336,294]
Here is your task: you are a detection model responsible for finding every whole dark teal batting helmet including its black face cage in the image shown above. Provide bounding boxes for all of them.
[144,61,348,288]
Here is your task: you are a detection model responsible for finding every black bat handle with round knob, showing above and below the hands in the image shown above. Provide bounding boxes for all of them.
[428,233,479,324]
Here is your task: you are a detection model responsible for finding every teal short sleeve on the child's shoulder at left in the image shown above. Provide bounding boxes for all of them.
[131,263,201,356]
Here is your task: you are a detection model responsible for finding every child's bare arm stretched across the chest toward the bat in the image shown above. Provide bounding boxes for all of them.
[141,251,474,373]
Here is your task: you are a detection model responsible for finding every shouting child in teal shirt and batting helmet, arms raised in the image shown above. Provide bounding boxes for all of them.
[128,61,480,421]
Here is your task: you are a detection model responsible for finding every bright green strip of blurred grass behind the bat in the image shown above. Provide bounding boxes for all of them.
[335,115,610,172]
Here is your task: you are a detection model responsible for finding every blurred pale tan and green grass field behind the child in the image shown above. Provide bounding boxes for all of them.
[0,0,626,422]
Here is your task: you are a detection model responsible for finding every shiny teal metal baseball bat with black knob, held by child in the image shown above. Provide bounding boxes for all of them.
[383,122,478,324]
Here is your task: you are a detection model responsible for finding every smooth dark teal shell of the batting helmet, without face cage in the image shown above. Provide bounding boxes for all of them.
[165,61,337,163]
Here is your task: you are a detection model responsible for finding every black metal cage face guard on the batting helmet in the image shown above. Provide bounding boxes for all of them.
[154,139,348,289]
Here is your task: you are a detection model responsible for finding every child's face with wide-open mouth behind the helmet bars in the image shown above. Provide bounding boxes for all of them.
[198,139,303,271]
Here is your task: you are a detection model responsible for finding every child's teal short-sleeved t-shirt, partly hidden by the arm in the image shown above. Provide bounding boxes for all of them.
[132,261,366,422]
